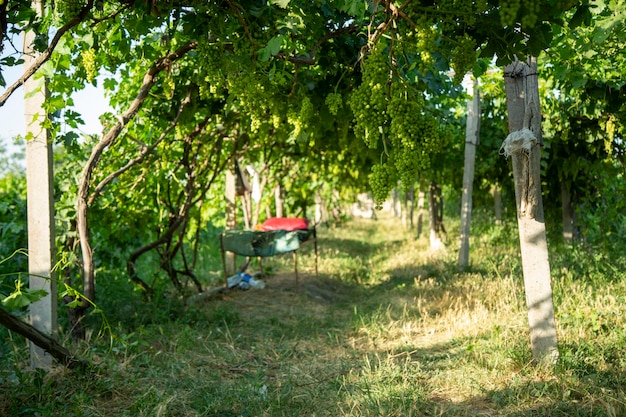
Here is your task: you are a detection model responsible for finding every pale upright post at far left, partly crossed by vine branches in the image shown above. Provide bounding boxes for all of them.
[24,0,57,369]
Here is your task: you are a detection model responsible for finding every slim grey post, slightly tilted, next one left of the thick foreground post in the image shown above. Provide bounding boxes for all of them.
[458,80,480,271]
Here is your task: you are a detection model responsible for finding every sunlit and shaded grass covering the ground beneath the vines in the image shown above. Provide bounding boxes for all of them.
[0,210,626,417]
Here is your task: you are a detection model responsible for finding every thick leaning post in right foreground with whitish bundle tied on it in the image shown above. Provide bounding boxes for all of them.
[501,57,558,363]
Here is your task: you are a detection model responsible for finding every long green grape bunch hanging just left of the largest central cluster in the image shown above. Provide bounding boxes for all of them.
[348,45,390,148]
